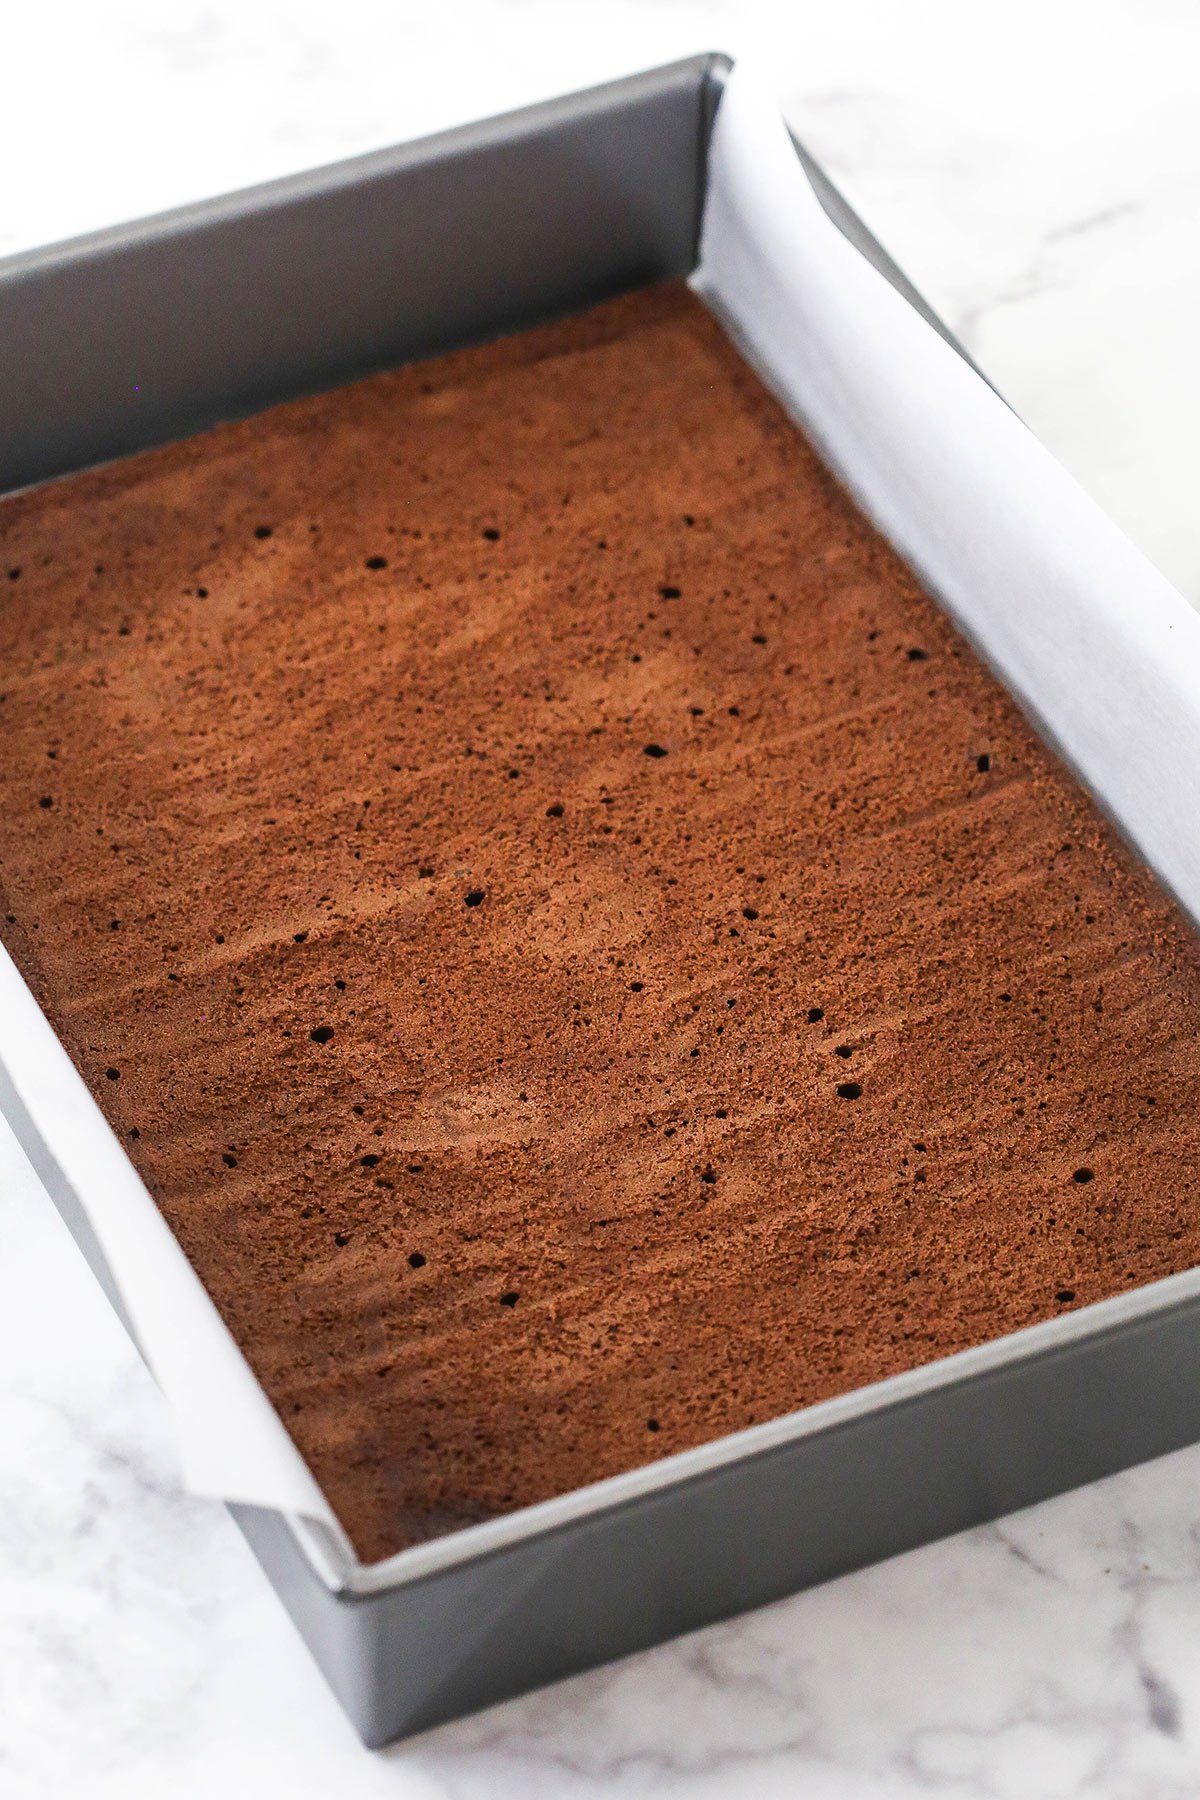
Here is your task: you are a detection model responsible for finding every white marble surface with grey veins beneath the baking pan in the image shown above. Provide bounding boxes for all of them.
[0,0,1200,1800]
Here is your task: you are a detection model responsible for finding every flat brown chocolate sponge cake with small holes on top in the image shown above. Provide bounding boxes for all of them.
[0,286,1200,1557]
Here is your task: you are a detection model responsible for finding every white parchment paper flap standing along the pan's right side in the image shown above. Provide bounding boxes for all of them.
[693,65,1200,918]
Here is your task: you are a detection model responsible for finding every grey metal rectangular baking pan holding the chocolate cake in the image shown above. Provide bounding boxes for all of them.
[0,56,1200,1744]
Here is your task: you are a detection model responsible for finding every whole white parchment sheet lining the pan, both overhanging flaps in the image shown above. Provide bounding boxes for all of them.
[0,67,1200,1543]
